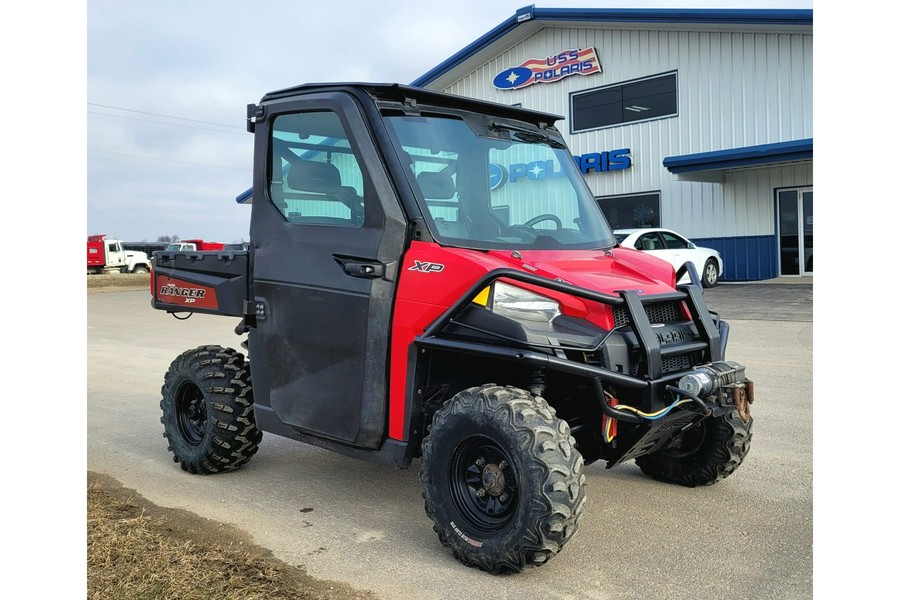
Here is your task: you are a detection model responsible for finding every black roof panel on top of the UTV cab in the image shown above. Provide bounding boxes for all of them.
[260,82,563,125]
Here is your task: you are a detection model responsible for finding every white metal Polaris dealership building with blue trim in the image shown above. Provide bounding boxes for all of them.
[412,6,813,281]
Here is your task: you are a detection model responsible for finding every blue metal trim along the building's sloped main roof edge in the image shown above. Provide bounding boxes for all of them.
[410,4,813,87]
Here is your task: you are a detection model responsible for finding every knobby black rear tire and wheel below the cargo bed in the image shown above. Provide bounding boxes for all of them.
[160,346,262,474]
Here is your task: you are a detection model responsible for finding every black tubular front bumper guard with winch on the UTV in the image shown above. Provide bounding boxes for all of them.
[415,269,754,467]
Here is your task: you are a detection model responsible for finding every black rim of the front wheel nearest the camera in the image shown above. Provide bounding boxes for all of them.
[450,436,519,531]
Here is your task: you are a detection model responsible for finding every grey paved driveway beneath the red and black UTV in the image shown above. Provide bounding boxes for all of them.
[87,283,813,600]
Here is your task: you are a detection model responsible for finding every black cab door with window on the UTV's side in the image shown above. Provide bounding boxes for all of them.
[249,92,406,448]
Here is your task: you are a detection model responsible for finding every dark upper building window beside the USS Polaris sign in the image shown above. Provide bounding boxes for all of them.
[569,71,678,133]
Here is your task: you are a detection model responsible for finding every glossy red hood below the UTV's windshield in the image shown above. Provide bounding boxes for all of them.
[478,248,675,295]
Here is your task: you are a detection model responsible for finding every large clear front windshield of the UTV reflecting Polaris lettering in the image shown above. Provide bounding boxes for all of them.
[385,116,616,250]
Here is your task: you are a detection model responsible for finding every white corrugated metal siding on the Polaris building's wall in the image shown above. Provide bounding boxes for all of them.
[446,26,813,241]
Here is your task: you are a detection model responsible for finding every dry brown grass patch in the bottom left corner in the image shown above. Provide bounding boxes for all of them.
[87,473,375,600]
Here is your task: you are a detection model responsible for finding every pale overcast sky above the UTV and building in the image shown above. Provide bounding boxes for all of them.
[85,0,812,242]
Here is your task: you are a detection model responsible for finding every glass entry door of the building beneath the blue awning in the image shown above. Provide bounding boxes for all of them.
[777,188,813,275]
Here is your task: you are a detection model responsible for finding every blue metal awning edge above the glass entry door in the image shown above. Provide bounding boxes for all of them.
[663,138,813,173]
